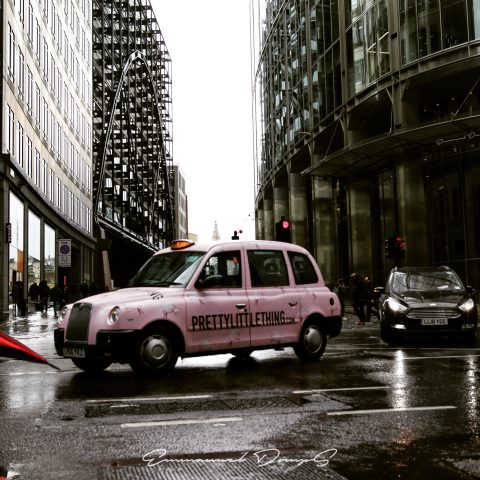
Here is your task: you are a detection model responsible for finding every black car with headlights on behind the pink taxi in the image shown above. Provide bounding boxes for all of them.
[375,266,478,343]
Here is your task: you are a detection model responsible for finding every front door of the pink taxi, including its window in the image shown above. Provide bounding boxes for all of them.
[186,247,250,352]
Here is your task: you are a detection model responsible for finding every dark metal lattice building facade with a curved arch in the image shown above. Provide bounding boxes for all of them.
[93,0,173,251]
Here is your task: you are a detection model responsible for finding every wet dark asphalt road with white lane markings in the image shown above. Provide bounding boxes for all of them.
[0,314,480,480]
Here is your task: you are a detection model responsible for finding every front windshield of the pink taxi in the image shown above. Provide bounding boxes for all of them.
[128,251,205,287]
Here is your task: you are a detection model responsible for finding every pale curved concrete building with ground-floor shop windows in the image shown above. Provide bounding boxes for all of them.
[0,0,95,315]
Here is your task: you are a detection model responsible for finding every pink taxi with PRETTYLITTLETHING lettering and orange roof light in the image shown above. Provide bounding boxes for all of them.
[54,240,342,374]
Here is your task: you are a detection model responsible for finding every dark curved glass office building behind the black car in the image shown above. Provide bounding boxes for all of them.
[251,0,480,287]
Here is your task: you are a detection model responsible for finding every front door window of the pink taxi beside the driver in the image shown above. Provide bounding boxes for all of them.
[200,251,242,288]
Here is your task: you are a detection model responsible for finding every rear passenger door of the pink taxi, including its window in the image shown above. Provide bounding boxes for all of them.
[247,250,300,347]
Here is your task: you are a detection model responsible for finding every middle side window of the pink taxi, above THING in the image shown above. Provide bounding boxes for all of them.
[248,250,288,287]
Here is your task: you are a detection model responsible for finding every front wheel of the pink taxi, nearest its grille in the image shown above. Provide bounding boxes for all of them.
[130,327,178,375]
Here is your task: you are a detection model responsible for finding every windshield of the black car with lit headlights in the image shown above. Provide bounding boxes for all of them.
[391,271,464,293]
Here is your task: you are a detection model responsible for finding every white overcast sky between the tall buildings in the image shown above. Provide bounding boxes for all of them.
[151,0,255,241]
